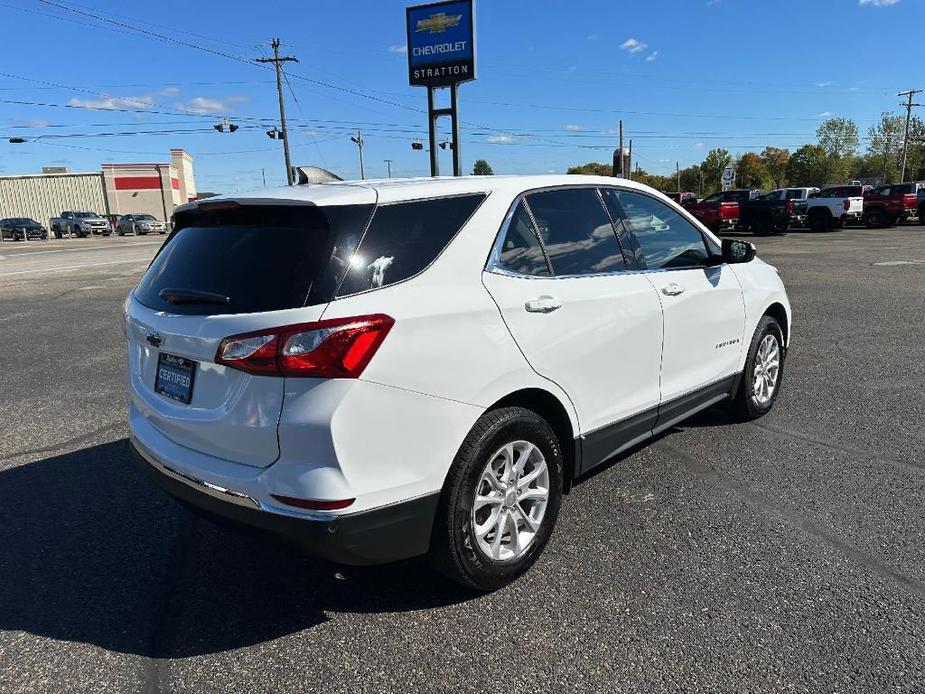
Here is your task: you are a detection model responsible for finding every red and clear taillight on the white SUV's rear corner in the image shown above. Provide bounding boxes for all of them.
[215,314,395,378]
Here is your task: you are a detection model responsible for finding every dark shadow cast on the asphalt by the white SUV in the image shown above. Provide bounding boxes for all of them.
[0,439,476,658]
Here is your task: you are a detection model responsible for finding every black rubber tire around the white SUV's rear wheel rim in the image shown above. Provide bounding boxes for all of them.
[430,407,563,592]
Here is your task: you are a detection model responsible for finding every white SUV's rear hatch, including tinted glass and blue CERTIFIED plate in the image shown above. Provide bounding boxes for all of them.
[126,196,375,467]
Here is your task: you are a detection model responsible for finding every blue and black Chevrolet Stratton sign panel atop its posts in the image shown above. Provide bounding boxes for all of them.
[405,0,475,87]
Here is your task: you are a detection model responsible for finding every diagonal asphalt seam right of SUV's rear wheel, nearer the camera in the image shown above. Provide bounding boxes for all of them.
[653,441,925,597]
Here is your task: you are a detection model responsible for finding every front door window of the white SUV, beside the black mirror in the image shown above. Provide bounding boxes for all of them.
[616,190,709,270]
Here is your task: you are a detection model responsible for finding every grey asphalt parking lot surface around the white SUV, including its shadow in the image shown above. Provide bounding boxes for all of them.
[0,226,925,693]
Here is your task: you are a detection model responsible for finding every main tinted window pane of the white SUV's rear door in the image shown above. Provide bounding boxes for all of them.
[527,188,626,275]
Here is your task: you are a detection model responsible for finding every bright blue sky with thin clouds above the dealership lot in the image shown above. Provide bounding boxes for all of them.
[0,0,925,192]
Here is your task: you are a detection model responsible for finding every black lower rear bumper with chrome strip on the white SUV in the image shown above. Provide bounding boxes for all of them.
[130,437,440,566]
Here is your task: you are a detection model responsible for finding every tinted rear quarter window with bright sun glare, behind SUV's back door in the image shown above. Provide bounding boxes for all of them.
[337,194,485,296]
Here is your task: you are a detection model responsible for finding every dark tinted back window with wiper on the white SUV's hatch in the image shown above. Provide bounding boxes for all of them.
[134,205,373,315]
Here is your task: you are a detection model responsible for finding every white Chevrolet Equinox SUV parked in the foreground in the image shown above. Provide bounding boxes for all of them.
[124,176,791,590]
